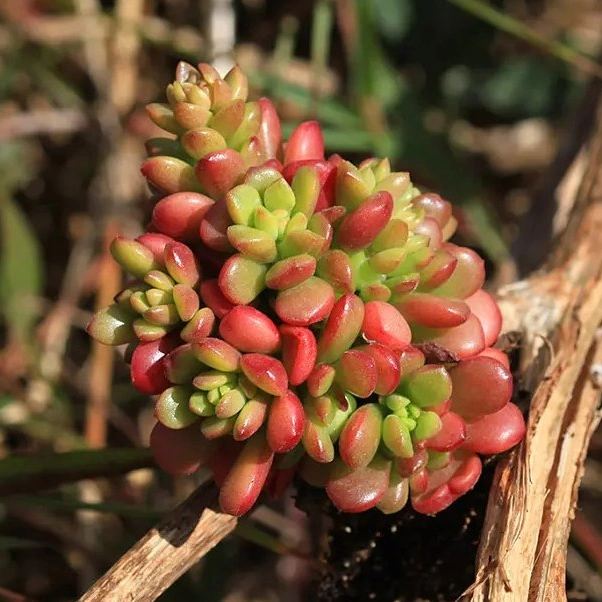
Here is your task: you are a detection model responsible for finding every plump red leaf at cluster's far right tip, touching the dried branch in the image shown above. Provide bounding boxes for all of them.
[463,403,526,454]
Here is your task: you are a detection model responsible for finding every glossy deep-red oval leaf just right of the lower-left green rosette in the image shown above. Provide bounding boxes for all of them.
[267,391,305,454]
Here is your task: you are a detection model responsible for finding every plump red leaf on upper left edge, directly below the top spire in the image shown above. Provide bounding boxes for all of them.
[153,192,214,242]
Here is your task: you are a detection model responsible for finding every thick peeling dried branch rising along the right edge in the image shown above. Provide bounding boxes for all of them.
[463,96,602,602]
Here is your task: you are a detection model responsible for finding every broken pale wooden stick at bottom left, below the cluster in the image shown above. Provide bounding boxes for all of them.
[79,484,237,602]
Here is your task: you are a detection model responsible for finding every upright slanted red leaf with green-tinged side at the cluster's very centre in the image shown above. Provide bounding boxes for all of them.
[318,293,364,363]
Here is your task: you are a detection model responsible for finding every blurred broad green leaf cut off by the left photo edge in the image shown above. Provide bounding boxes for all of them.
[0,196,42,342]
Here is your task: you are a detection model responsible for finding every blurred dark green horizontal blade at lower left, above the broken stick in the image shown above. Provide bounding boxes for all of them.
[0,448,154,495]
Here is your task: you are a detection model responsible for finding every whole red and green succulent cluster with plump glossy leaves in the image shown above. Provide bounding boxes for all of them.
[89,63,525,515]
